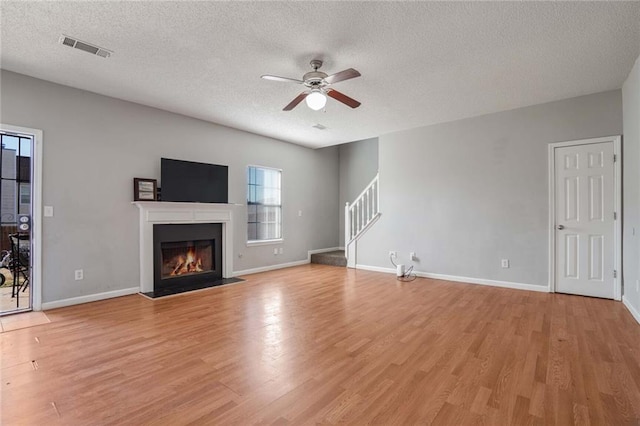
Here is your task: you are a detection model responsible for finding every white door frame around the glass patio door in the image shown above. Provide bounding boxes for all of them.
[0,123,42,311]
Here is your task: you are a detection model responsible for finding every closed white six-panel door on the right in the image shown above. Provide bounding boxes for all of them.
[555,142,615,299]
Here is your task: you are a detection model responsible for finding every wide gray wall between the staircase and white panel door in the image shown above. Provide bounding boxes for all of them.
[357,90,622,286]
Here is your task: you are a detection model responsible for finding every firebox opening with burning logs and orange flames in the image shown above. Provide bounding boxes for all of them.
[162,243,213,278]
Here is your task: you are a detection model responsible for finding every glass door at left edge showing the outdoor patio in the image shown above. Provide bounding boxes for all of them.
[0,131,33,315]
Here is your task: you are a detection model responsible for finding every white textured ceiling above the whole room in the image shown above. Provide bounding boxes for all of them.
[0,1,640,147]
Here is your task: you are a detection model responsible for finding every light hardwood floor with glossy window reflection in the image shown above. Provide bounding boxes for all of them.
[0,265,640,425]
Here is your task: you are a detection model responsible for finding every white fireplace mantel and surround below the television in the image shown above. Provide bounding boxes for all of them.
[133,201,235,293]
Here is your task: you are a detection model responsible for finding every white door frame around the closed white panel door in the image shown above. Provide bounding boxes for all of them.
[548,135,622,300]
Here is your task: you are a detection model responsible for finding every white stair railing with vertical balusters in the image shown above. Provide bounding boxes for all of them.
[344,174,380,268]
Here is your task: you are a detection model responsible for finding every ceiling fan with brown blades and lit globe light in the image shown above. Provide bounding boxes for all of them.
[262,59,360,111]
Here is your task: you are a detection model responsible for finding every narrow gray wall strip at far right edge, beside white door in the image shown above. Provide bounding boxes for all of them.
[622,58,640,312]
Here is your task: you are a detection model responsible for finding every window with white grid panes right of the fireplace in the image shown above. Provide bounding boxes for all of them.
[247,166,282,242]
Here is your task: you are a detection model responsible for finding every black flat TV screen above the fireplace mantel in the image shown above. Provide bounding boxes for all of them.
[160,158,229,203]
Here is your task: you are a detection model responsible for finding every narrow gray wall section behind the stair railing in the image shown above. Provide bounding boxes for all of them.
[338,138,378,247]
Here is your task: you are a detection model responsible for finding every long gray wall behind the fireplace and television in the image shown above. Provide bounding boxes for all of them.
[0,71,339,302]
